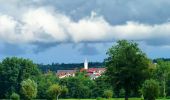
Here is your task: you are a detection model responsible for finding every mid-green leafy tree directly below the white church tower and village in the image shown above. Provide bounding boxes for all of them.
[60,74,94,98]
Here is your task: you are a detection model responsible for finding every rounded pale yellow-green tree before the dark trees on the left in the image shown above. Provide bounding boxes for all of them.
[21,79,37,100]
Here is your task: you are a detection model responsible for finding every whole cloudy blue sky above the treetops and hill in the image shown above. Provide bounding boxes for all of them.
[0,0,170,64]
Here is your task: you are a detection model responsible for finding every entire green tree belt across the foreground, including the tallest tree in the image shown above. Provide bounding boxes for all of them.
[0,40,170,100]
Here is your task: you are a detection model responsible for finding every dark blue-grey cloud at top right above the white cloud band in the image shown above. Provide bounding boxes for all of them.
[33,0,170,24]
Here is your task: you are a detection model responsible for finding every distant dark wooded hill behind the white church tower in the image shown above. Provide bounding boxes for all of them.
[37,62,104,72]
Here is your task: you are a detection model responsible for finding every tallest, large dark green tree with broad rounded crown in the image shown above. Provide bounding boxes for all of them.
[105,40,150,100]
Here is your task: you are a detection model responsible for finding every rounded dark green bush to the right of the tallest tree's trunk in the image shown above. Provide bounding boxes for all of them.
[142,79,159,100]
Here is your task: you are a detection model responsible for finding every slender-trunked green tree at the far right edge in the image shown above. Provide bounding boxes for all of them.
[155,60,170,98]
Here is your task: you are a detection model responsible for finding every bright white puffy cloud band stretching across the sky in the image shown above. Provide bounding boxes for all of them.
[0,8,170,44]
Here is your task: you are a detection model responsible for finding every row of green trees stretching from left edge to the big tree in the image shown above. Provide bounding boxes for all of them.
[0,57,111,100]
